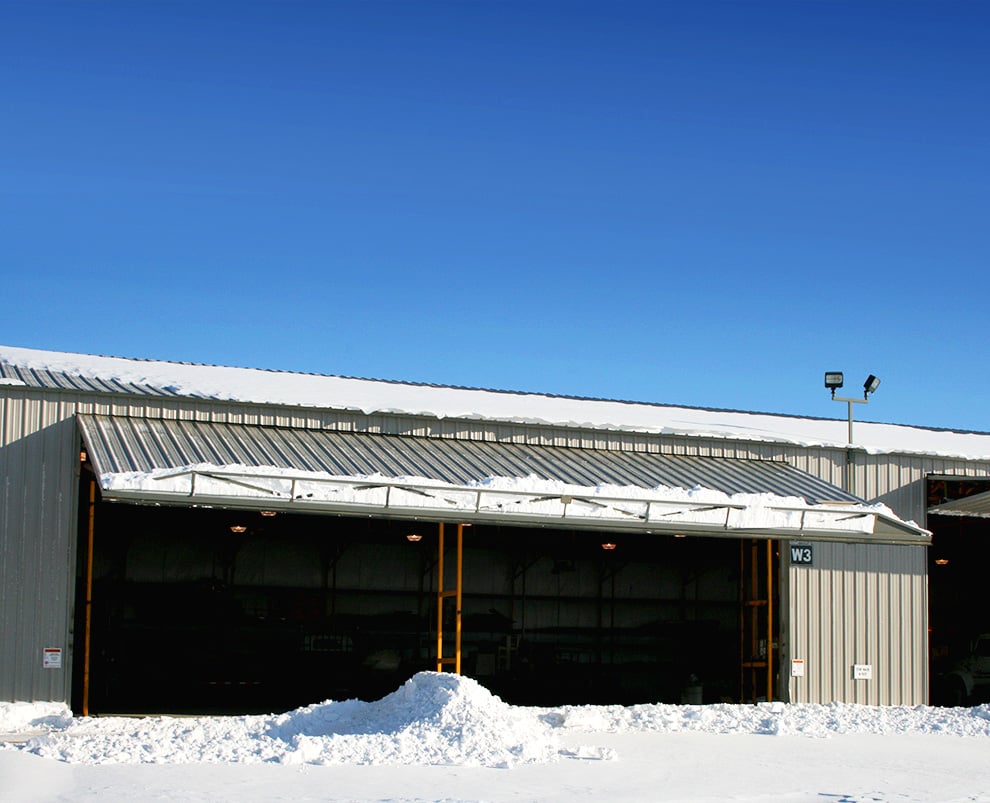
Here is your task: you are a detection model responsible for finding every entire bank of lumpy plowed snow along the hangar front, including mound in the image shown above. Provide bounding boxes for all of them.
[0,672,990,767]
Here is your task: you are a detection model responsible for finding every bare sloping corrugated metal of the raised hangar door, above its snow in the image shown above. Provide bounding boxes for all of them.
[80,416,868,503]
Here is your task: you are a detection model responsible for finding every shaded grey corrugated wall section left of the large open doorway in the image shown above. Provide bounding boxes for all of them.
[0,394,79,701]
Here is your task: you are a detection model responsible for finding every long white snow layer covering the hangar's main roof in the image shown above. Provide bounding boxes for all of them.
[0,346,990,460]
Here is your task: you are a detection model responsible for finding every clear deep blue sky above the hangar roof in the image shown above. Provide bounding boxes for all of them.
[0,0,990,430]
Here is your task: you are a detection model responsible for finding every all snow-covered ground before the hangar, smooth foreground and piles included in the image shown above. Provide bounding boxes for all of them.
[0,673,990,803]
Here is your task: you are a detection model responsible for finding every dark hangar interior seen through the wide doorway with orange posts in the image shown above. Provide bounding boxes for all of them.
[74,502,776,713]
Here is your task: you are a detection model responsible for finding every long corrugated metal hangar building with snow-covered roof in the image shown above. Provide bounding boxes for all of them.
[0,347,990,714]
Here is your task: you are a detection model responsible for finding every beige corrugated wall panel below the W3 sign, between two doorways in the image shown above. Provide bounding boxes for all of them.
[783,543,928,705]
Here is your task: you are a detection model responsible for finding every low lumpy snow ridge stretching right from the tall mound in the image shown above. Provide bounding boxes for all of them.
[542,702,990,738]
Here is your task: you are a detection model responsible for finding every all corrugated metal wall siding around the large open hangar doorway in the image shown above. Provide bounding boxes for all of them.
[0,382,976,704]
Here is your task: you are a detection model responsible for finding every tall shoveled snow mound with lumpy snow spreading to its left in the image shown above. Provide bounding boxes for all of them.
[9,672,558,767]
